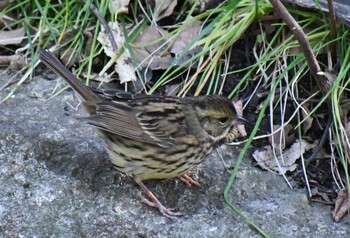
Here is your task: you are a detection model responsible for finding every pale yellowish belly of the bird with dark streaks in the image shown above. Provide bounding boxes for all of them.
[107,137,212,181]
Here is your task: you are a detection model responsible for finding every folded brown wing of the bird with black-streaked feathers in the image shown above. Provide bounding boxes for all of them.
[84,97,187,147]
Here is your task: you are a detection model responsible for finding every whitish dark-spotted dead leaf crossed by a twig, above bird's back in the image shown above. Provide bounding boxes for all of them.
[97,22,137,83]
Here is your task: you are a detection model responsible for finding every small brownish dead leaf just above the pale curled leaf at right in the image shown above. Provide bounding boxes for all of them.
[269,124,295,149]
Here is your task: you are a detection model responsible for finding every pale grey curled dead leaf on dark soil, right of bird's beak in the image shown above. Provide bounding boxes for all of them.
[253,140,316,175]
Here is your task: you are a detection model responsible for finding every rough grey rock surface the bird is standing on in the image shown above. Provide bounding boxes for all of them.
[0,73,350,237]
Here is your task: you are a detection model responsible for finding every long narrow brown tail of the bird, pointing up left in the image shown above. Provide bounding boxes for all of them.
[39,49,98,101]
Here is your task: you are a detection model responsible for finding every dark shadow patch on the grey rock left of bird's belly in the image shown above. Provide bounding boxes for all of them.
[34,136,122,191]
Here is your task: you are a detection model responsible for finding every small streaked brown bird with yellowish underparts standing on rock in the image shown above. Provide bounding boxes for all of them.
[39,49,245,218]
